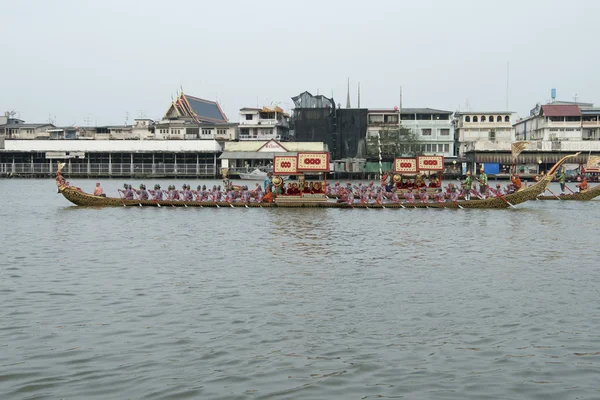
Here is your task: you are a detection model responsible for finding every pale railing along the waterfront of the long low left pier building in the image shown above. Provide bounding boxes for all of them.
[0,162,218,177]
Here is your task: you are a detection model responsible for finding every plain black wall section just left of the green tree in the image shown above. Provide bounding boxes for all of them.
[332,108,368,160]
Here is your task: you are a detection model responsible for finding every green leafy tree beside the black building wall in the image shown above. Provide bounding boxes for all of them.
[366,127,424,159]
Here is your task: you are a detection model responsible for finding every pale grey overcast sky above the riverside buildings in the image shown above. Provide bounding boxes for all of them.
[0,0,600,125]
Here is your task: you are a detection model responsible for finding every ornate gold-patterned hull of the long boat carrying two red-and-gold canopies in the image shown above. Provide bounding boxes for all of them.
[58,153,579,209]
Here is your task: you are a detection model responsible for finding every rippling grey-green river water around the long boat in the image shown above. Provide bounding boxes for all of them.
[0,179,600,399]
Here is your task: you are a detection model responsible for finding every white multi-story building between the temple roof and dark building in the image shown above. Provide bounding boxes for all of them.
[239,106,290,141]
